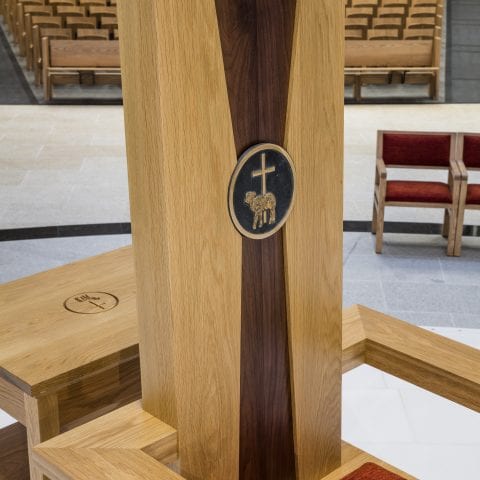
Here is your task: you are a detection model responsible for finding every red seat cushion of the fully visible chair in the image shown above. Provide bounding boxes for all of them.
[386,180,452,203]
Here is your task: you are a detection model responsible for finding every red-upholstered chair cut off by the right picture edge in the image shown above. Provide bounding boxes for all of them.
[455,133,480,256]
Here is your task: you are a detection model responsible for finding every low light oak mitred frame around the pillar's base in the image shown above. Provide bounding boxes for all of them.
[34,305,480,480]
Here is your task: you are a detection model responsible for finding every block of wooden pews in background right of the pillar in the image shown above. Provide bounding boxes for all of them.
[345,0,443,101]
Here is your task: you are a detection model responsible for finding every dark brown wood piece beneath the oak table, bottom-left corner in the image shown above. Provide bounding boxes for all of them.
[0,423,30,480]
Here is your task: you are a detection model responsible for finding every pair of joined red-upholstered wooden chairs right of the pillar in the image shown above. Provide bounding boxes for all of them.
[372,131,480,256]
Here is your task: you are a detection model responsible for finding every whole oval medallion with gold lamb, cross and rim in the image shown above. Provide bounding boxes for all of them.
[228,143,295,240]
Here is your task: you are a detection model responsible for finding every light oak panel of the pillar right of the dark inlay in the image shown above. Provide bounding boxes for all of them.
[284,0,344,480]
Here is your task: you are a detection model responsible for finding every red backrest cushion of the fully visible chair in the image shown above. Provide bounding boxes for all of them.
[383,133,451,167]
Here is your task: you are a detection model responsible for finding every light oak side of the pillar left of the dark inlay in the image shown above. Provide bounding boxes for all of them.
[118,0,241,480]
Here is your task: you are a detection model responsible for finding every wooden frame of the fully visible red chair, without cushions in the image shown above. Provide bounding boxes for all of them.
[372,130,462,256]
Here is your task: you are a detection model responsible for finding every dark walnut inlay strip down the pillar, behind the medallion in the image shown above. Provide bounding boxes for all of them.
[216,0,296,480]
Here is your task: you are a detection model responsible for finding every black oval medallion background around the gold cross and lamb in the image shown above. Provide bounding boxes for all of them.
[230,145,295,238]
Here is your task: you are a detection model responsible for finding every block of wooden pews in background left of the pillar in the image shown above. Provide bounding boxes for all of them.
[0,0,120,101]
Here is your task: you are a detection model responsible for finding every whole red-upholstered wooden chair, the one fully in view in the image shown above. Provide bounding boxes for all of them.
[372,127,462,255]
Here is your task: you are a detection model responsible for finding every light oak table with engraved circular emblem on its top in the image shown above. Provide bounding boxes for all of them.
[0,247,141,480]
